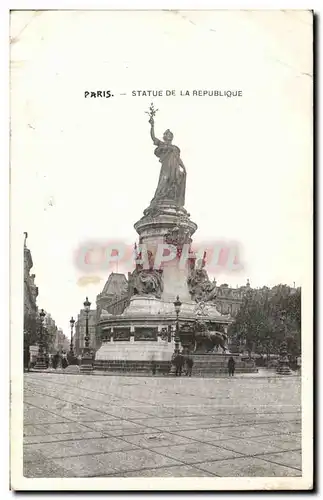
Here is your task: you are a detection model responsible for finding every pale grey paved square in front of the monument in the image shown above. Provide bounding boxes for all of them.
[24,373,302,478]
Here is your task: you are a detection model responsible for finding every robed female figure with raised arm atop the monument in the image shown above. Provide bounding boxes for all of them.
[149,115,186,207]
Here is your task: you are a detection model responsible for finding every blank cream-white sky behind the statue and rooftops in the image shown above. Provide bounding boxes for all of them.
[10,11,313,334]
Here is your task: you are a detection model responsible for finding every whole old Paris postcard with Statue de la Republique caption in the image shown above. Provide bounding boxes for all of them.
[10,10,314,491]
